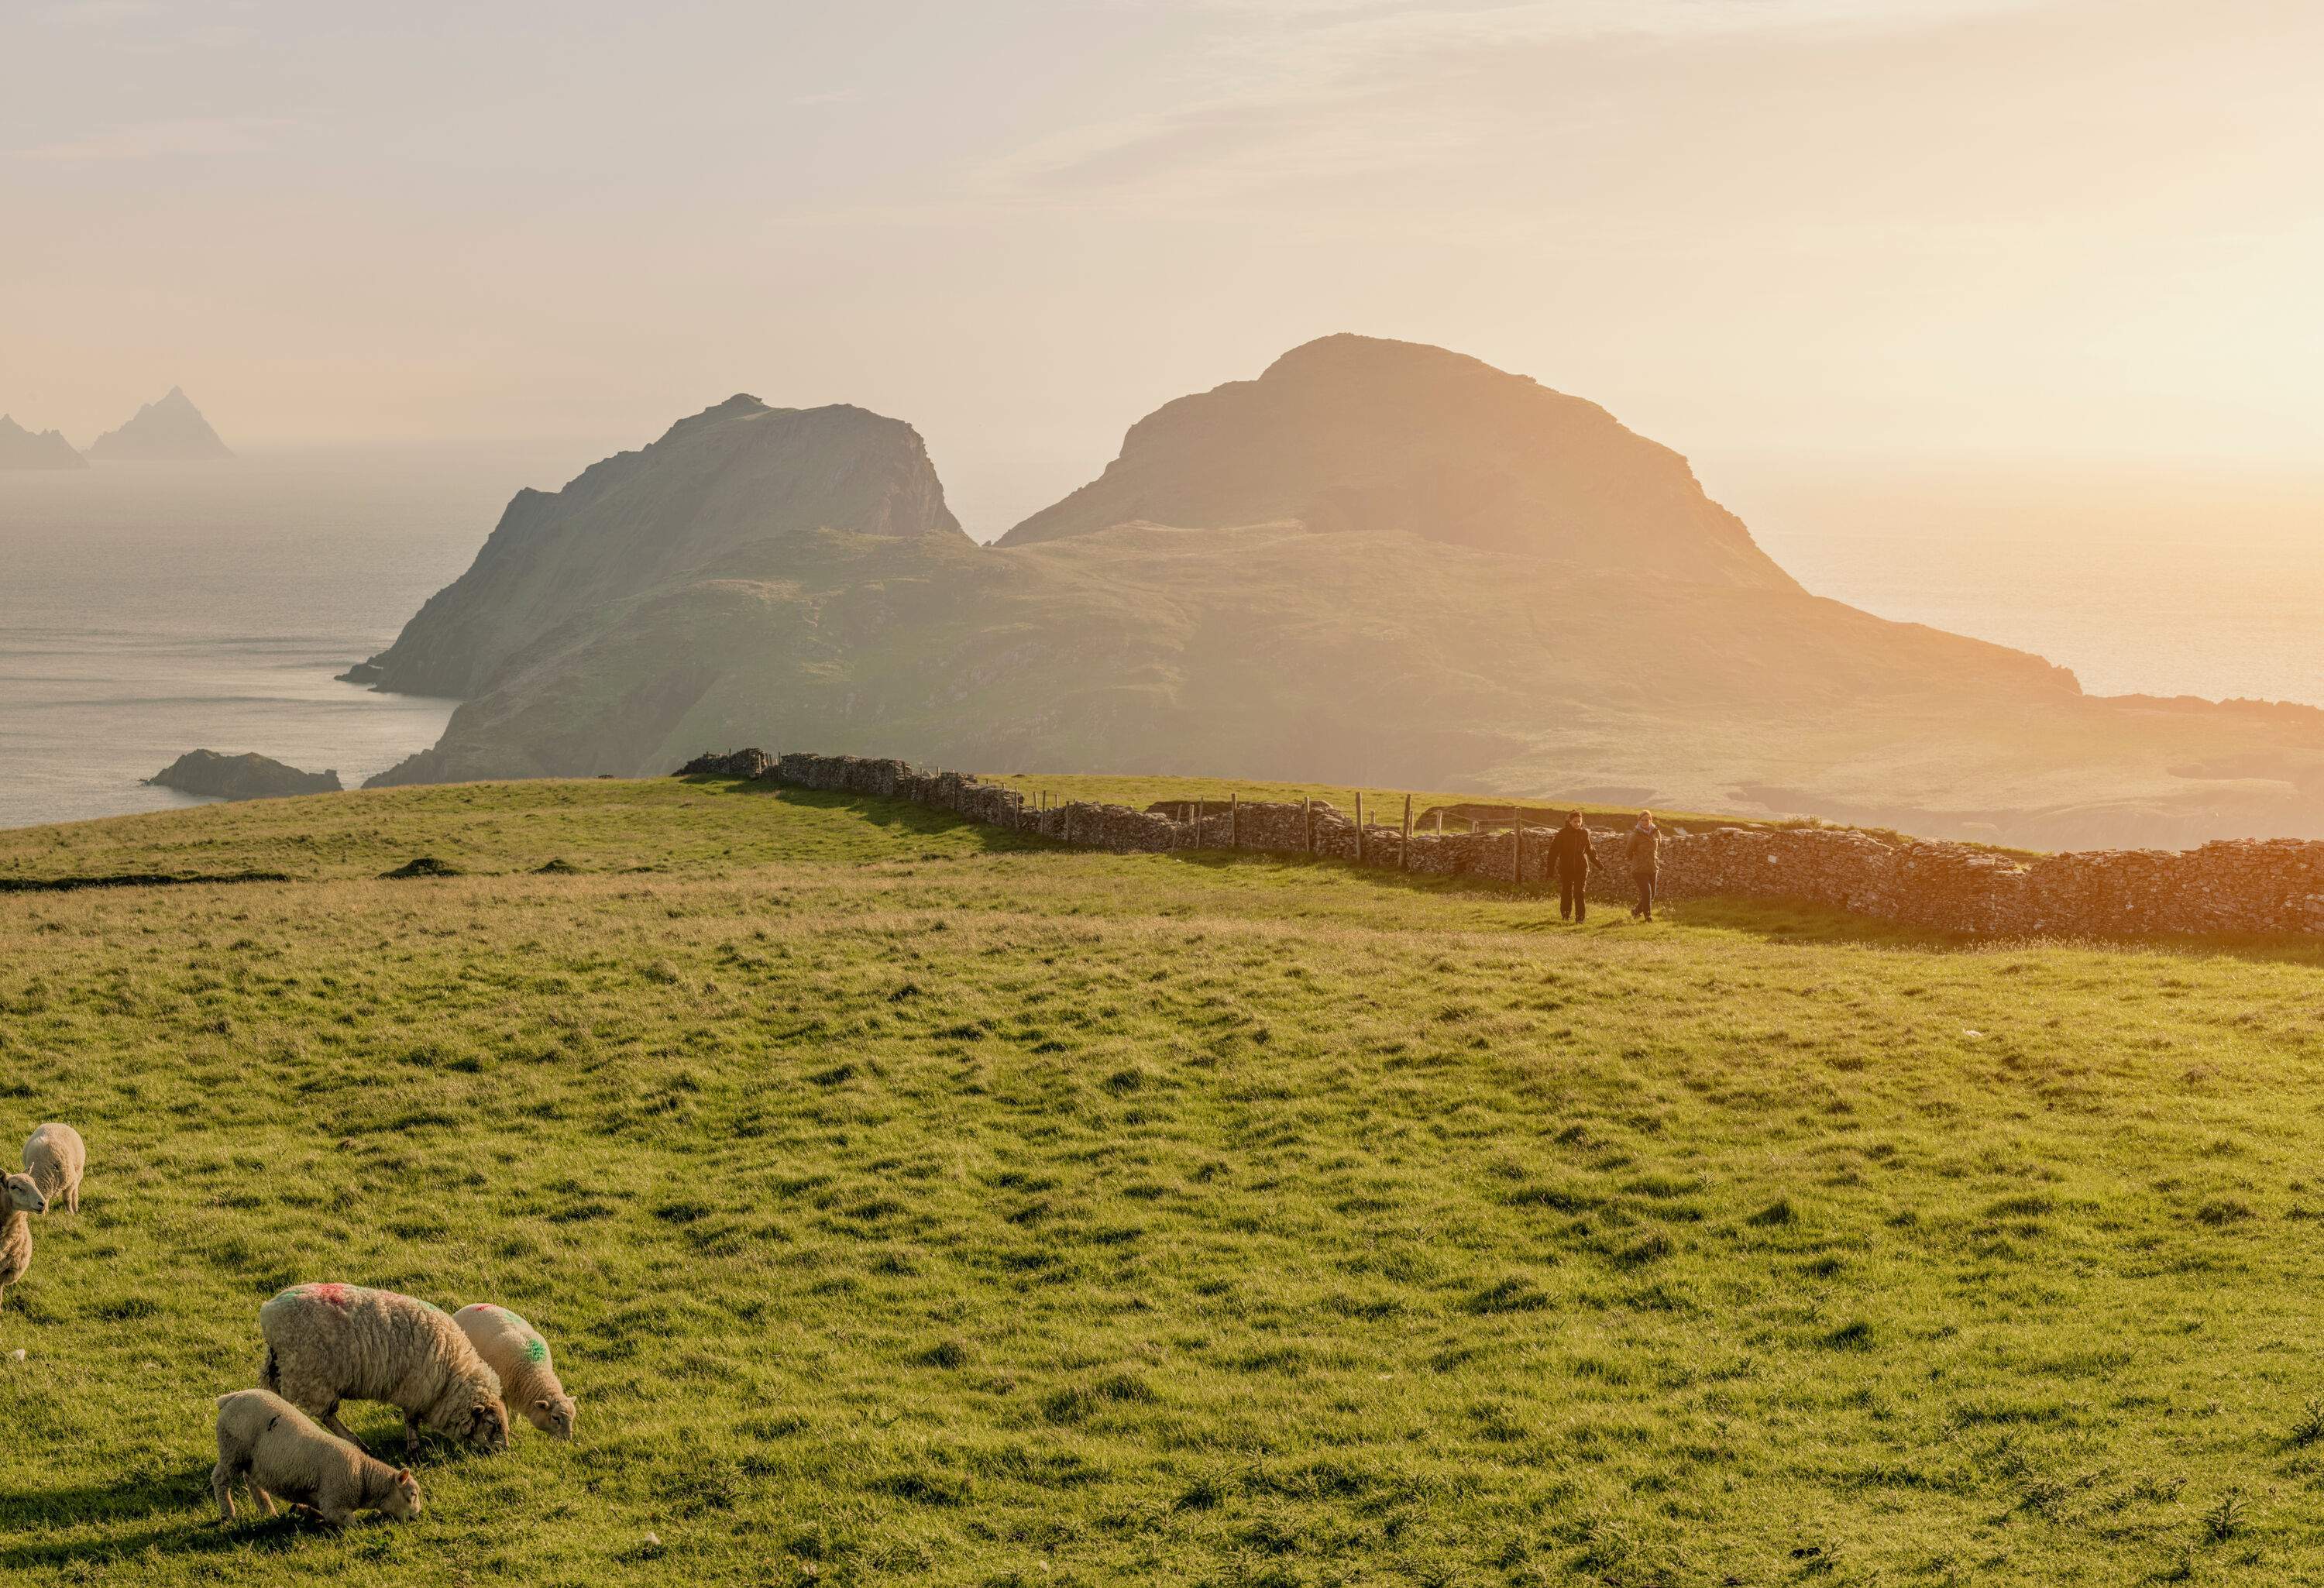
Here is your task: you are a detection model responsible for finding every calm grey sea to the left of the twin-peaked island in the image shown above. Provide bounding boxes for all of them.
[0,446,604,828]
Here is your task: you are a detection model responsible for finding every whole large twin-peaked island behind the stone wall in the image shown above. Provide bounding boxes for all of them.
[349,335,2324,849]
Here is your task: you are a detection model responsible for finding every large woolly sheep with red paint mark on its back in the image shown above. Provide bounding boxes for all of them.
[258,1286,509,1451]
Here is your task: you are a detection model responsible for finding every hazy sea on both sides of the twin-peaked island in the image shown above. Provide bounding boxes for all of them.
[0,442,2324,828]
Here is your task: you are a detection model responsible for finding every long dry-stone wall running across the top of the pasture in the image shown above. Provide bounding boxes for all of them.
[681,751,2324,937]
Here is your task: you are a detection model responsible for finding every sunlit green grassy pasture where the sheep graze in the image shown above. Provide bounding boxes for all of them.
[0,779,2324,1588]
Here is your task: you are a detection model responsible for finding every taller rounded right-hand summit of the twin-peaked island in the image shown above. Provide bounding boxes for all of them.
[999,335,1796,590]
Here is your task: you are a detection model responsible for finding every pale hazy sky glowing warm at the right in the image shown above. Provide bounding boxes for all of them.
[0,0,2324,532]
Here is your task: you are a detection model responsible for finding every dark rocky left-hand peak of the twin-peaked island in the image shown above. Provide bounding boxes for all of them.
[344,395,974,697]
